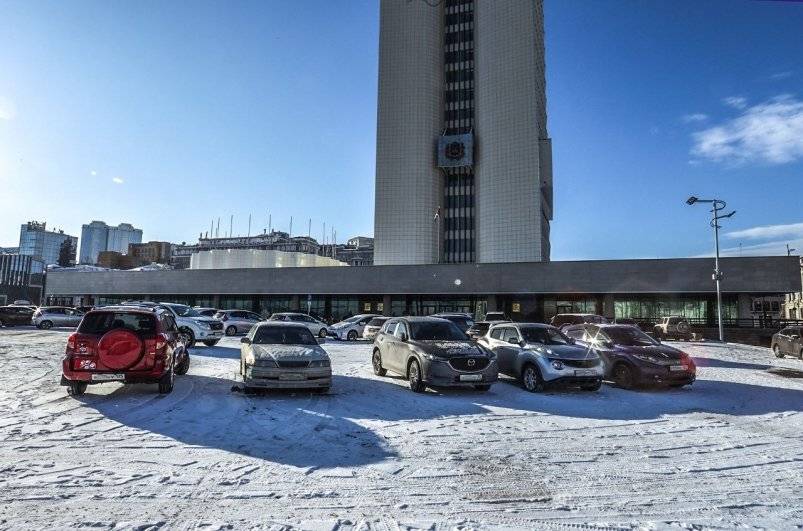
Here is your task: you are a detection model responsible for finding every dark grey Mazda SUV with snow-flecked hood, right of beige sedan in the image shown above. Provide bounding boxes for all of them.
[372,317,498,393]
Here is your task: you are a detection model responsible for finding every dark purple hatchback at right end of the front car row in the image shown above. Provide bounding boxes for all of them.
[565,324,697,389]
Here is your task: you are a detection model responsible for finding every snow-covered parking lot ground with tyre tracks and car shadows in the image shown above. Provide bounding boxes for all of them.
[0,328,803,529]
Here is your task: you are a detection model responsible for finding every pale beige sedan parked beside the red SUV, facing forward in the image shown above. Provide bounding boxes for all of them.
[240,321,332,392]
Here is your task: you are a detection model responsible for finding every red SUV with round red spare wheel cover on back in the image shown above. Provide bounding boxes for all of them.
[61,306,190,396]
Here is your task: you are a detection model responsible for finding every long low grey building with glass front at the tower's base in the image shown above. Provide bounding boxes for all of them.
[47,257,801,323]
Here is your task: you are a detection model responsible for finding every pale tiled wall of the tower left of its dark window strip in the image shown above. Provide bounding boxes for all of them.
[374,0,443,265]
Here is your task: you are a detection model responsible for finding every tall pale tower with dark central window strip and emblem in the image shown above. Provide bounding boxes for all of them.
[374,0,552,265]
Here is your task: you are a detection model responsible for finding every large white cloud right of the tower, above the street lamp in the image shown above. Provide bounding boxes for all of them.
[691,94,803,164]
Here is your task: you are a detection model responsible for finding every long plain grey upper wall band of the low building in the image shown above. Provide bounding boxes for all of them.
[46,256,801,296]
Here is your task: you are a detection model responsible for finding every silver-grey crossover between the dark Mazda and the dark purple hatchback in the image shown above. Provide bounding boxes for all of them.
[479,323,603,393]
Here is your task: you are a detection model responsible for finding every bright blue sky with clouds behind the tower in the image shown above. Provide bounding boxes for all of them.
[0,0,803,260]
